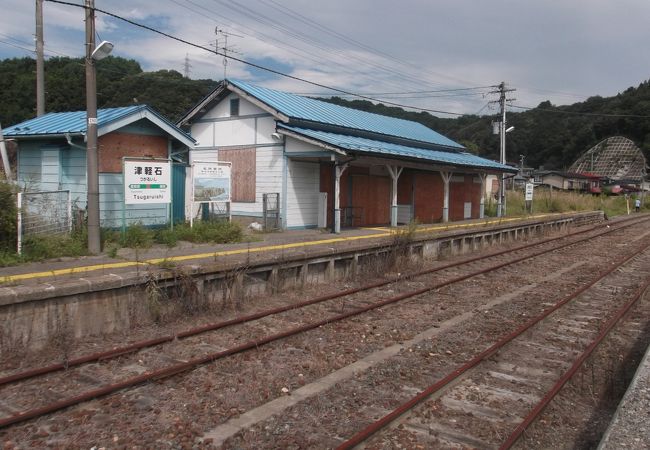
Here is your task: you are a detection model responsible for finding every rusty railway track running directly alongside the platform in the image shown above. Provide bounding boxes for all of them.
[0,215,639,446]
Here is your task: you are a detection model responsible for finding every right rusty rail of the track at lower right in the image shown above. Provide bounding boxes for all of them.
[499,278,650,450]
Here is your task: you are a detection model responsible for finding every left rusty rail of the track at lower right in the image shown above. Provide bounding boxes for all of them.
[336,237,650,450]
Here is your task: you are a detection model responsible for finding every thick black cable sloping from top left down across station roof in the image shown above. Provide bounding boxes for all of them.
[46,0,465,116]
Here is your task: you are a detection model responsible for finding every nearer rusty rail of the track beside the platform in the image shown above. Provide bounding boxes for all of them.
[0,216,636,429]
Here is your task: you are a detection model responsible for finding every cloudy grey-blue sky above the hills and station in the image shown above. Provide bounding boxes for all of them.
[0,0,650,117]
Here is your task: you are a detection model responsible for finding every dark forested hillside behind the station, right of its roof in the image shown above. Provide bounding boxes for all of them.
[330,81,650,169]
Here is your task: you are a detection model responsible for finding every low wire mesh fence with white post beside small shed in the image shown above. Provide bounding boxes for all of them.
[16,190,72,254]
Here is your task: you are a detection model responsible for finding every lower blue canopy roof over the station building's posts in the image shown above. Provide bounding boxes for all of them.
[278,124,517,172]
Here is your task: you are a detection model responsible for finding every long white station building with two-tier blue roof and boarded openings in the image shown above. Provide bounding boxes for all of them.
[178,80,517,231]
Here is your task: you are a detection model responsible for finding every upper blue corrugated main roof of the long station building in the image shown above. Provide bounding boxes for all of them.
[228,80,464,150]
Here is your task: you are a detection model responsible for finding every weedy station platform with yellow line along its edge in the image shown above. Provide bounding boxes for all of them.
[0,214,567,287]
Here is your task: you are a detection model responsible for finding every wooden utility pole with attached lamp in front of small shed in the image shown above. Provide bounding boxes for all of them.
[85,0,113,254]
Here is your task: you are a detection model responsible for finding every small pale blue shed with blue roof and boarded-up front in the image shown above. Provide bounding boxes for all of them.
[4,105,194,227]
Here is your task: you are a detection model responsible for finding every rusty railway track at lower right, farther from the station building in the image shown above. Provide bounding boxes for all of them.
[338,232,650,450]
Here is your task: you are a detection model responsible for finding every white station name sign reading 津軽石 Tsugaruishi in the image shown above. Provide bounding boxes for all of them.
[124,159,172,205]
